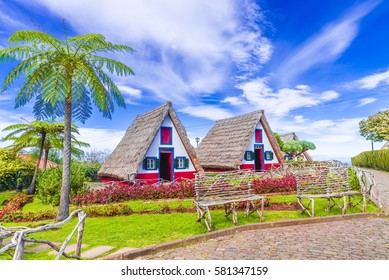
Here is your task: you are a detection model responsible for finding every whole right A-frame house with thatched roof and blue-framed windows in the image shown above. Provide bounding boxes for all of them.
[196,110,284,171]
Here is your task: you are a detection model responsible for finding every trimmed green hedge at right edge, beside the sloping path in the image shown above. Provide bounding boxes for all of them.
[351,149,389,171]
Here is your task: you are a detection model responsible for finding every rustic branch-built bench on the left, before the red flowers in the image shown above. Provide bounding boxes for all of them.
[195,171,264,231]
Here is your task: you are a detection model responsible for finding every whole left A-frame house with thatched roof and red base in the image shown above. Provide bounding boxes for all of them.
[98,102,203,182]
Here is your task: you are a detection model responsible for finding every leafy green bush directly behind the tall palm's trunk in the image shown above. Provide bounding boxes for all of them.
[37,162,90,206]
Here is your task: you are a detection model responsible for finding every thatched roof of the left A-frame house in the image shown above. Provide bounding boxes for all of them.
[98,102,202,180]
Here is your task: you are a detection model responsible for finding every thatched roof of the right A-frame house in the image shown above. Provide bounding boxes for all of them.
[196,110,284,169]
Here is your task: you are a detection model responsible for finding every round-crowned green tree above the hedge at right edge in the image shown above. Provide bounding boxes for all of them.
[359,110,389,149]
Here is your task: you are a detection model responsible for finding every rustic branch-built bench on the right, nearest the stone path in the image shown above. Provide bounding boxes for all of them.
[294,166,366,217]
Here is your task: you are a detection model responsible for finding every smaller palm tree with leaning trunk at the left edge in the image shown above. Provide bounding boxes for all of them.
[2,121,64,194]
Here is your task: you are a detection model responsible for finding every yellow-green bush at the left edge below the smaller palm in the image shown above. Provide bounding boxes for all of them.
[0,148,35,191]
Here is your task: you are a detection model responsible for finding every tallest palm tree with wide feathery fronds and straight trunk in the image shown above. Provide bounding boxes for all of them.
[0,31,134,221]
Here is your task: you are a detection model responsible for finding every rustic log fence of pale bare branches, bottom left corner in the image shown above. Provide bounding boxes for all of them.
[0,209,86,260]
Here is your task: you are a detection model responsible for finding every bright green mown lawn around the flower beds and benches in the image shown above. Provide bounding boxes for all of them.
[0,193,377,260]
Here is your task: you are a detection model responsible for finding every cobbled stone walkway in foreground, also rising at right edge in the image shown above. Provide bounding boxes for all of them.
[130,167,389,260]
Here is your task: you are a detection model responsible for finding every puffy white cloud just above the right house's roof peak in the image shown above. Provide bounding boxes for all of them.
[222,78,339,116]
